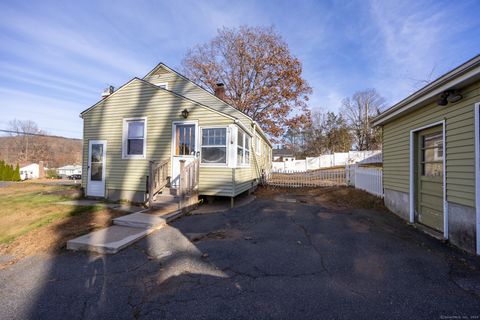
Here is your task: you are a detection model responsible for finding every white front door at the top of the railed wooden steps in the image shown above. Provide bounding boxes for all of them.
[171,121,199,188]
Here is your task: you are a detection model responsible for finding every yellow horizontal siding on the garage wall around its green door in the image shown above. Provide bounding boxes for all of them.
[383,82,480,207]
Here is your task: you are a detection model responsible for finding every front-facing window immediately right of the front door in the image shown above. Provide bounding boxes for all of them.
[201,128,227,164]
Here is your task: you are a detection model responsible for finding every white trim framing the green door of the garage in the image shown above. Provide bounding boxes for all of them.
[409,120,448,239]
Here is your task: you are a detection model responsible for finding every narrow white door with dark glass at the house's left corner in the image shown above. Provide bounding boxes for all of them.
[87,140,107,197]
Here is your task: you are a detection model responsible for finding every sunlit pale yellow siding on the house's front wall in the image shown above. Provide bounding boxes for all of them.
[83,80,233,199]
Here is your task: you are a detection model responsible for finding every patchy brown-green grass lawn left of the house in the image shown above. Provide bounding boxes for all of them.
[0,182,124,262]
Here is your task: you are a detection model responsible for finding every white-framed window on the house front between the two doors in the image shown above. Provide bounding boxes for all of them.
[123,118,146,159]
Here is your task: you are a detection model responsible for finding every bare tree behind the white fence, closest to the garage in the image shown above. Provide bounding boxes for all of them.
[342,89,385,150]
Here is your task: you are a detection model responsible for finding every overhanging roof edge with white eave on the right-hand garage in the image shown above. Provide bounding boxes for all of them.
[373,55,480,126]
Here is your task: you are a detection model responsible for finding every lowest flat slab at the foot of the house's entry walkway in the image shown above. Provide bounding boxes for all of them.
[67,225,156,254]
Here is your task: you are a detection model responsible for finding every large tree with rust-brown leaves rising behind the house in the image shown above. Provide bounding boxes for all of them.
[182,26,312,137]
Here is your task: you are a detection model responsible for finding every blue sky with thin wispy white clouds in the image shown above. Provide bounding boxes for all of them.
[0,0,480,138]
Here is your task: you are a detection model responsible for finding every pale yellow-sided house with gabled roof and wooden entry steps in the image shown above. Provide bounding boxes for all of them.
[81,64,272,202]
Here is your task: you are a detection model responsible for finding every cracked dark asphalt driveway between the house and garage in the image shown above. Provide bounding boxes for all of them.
[0,194,480,319]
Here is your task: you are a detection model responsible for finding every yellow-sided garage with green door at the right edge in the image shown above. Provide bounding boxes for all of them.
[374,55,480,254]
